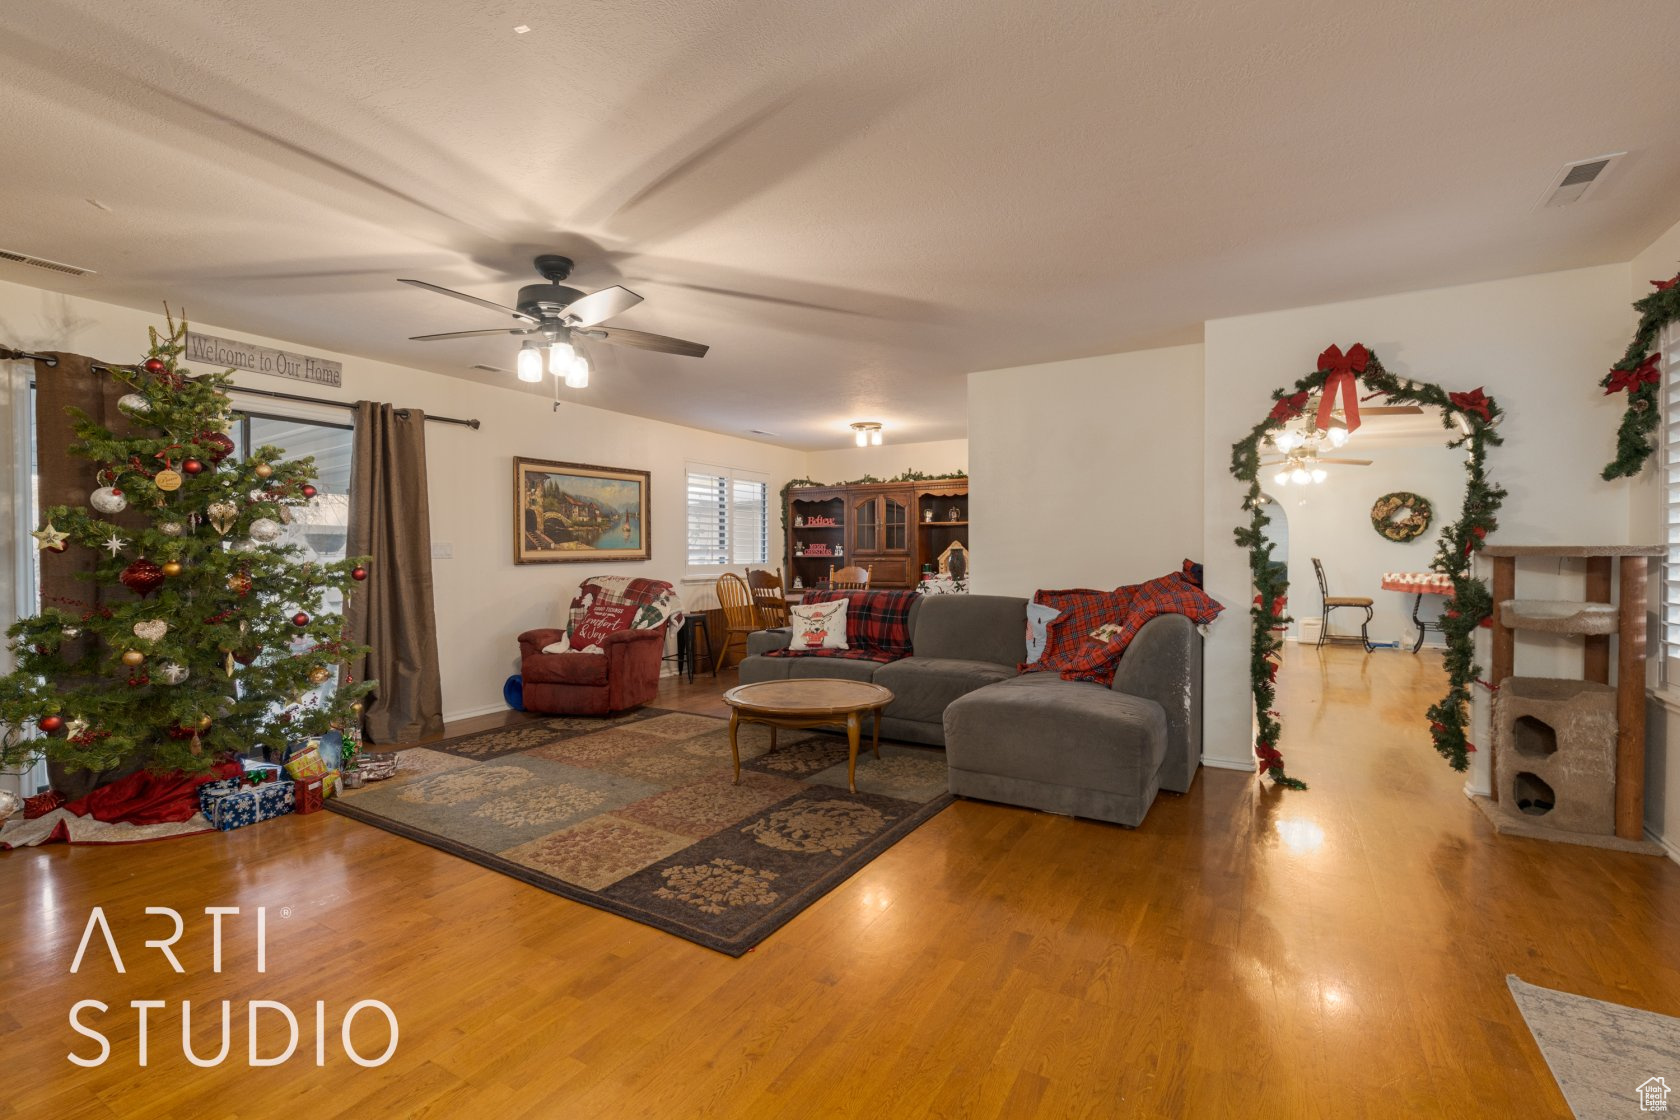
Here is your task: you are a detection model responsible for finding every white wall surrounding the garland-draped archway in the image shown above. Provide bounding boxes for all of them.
[1202,265,1628,789]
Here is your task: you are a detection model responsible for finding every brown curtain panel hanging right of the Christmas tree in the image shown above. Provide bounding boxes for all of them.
[344,401,444,742]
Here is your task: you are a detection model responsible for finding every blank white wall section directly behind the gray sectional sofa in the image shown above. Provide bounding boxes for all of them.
[968,346,1203,594]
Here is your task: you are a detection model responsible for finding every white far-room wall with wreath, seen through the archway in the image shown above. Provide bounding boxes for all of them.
[1262,432,1465,652]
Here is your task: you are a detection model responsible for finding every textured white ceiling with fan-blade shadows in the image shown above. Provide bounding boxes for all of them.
[0,0,1680,448]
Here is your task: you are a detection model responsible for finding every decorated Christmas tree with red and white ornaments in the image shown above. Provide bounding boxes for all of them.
[0,310,373,771]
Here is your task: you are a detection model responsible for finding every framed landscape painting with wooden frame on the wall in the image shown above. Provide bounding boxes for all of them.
[514,458,652,564]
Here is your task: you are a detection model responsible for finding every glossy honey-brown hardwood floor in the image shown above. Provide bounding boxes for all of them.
[0,648,1680,1120]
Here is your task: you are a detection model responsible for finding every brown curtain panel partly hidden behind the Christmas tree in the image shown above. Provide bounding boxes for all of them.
[34,353,150,801]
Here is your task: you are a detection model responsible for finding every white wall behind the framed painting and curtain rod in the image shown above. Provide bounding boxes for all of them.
[0,282,806,719]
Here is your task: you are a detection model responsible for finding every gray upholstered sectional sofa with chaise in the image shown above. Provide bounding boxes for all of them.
[741,594,1201,826]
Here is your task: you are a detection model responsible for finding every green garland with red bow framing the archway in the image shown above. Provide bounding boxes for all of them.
[1231,346,1505,789]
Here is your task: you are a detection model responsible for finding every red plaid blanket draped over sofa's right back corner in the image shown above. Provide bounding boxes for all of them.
[1016,571,1225,685]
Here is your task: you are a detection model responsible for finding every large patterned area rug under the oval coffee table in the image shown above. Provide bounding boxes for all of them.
[328,709,951,957]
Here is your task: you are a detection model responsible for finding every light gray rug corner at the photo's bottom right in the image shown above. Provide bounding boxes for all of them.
[1505,976,1680,1120]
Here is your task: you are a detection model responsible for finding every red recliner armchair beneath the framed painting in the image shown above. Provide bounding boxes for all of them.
[519,579,682,715]
